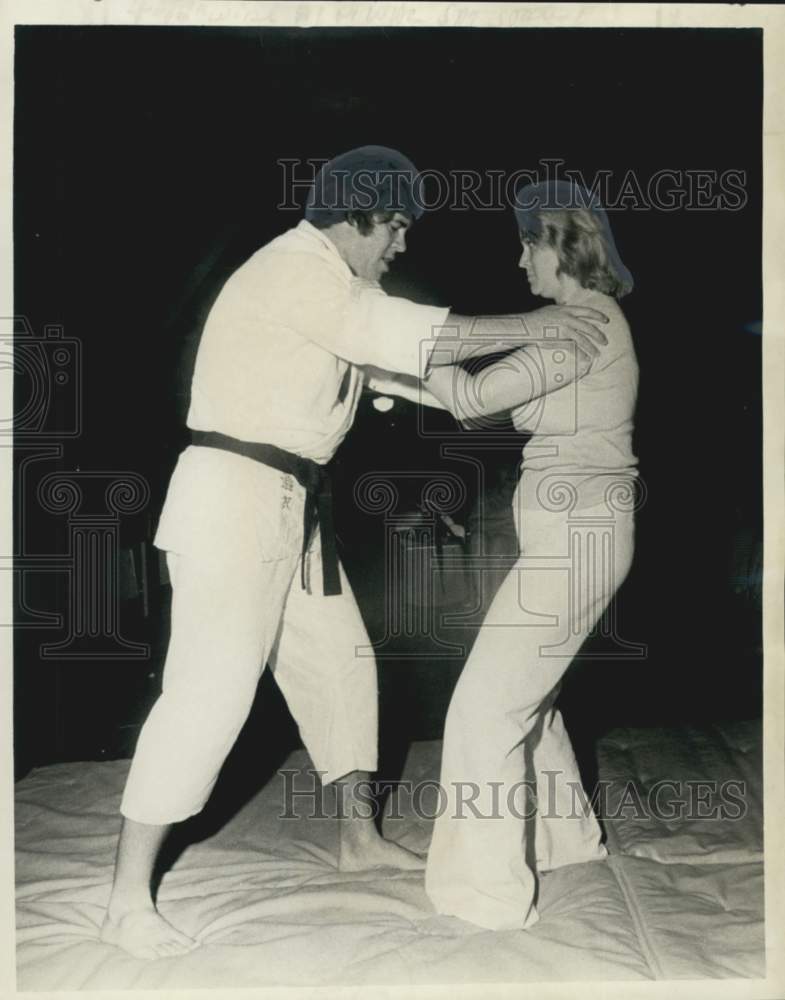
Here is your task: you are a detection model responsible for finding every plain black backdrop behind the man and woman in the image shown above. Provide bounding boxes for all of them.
[14,27,762,784]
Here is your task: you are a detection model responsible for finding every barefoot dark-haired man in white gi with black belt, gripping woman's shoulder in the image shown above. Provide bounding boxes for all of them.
[102,146,604,958]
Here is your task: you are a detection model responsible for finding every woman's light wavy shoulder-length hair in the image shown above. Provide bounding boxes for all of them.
[521,208,632,299]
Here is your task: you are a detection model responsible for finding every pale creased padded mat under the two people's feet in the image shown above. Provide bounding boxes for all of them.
[17,725,763,990]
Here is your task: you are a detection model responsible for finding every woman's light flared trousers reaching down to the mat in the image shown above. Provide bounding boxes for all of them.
[425,493,633,929]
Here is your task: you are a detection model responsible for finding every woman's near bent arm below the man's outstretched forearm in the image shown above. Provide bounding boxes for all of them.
[425,341,591,420]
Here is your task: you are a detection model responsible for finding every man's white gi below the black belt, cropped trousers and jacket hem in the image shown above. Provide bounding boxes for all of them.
[121,447,378,824]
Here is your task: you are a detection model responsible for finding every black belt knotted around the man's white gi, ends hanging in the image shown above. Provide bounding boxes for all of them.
[191,431,341,597]
